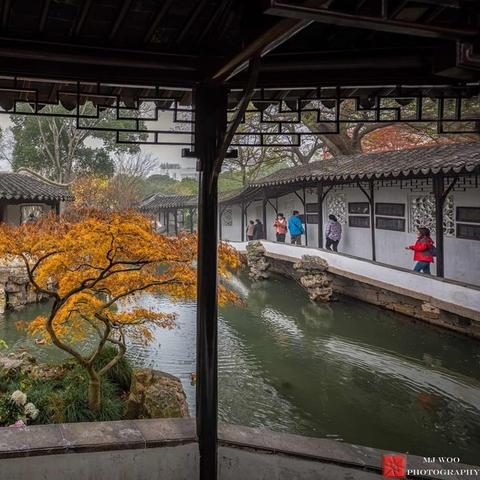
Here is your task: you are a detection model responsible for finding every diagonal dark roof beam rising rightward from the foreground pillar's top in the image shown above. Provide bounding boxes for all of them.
[211,19,312,82]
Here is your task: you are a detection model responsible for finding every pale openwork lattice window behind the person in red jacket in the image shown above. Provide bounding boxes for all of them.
[409,194,455,236]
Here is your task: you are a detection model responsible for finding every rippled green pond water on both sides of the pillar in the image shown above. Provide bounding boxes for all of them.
[0,275,480,464]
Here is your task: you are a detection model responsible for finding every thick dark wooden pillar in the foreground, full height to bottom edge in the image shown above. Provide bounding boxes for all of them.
[194,84,227,480]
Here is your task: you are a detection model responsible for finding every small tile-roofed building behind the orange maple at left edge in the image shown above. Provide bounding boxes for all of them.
[0,169,73,225]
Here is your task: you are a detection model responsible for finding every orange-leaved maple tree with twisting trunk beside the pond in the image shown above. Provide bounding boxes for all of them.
[0,212,239,410]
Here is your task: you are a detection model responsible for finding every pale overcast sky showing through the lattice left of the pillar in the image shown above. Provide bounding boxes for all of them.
[0,112,195,173]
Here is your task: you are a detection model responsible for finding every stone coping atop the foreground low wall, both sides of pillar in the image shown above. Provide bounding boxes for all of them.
[0,418,480,480]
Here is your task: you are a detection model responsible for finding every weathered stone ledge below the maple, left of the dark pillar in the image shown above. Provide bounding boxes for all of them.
[0,418,197,459]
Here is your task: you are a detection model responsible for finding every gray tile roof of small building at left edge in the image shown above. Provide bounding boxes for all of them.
[0,171,73,201]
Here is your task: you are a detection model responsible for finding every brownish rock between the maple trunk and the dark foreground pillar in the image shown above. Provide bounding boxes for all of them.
[126,368,189,419]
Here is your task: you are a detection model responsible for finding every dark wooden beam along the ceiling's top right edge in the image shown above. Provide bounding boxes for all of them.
[265,0,480,40]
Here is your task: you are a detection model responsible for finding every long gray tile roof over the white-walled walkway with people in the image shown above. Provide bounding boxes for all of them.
[249,142,480,187]
